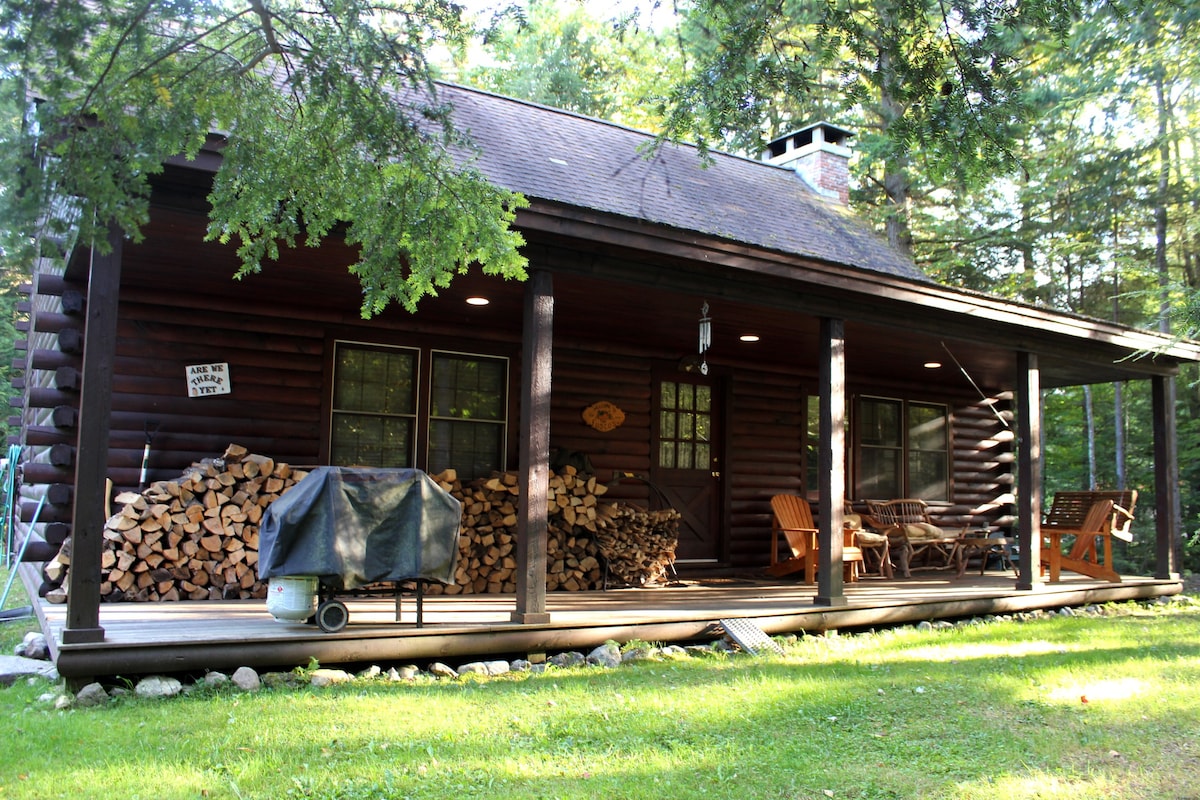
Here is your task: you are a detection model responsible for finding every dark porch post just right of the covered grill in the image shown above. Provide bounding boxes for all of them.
[512,270,554,625]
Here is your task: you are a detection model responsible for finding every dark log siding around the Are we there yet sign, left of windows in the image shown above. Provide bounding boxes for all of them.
[109,294,325,486]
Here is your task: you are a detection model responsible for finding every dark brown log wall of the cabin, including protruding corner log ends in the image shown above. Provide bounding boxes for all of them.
[9,203,1013,597]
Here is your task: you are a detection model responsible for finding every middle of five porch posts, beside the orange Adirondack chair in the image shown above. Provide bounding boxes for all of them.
[812,318,846,606]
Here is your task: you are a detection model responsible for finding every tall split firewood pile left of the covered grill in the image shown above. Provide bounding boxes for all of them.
[46,445,307,601]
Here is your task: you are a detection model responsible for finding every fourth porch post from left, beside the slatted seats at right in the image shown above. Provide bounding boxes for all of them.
[1016,353,1042,590]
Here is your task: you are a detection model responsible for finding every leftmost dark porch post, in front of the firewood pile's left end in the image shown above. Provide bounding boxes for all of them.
[62,225,125,644]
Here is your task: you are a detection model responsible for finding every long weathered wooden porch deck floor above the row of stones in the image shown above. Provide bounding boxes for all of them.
[25,572,1182,678]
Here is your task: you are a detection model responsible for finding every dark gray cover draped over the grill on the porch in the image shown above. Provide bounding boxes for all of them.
[258,467,462,590]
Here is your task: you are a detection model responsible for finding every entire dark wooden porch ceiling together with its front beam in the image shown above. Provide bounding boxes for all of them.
[122,193,1175,392]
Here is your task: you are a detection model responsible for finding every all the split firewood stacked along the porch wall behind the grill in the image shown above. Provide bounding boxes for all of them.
[46,445,679,602]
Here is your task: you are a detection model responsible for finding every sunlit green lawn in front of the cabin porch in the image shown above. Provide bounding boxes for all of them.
[0,566,1200,800]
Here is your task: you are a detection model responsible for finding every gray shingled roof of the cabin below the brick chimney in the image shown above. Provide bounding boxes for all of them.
[438,84,929,282]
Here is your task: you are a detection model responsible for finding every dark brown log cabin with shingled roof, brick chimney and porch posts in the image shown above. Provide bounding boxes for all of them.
[13,84,1200,643]
